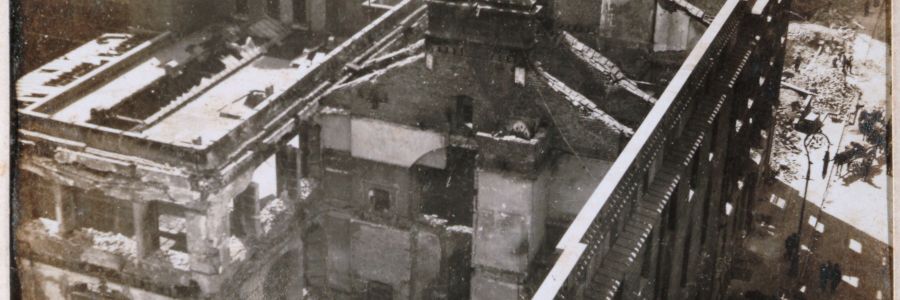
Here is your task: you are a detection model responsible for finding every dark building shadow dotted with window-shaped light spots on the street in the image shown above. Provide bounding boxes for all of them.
[732,177,892,299]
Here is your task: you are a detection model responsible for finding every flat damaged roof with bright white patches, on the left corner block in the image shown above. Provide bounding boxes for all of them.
[17,0,418,168]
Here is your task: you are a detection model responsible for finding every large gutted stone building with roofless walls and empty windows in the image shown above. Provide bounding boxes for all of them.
[15,0,790,299]
